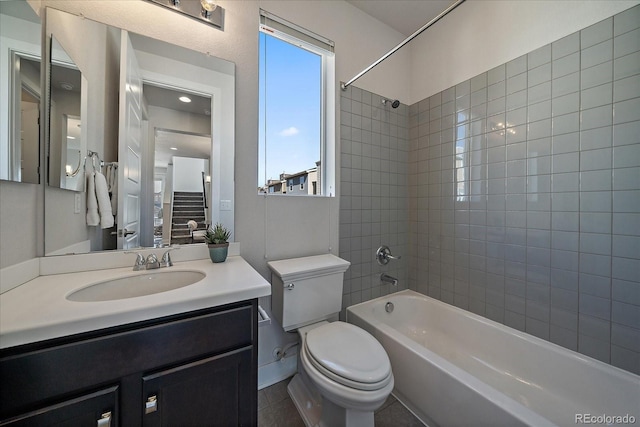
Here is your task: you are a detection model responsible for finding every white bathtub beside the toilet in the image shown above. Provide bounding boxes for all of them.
[347,290,640,427]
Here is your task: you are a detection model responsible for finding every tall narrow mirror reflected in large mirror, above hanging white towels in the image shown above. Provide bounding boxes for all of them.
[48,37,86,191]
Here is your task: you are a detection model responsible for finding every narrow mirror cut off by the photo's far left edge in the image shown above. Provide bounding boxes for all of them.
[0,1,42,184]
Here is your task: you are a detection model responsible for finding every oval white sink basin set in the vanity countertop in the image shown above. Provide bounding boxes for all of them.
[67,271,205,302]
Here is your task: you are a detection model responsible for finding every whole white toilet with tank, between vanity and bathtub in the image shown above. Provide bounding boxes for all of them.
[268,254,393,427]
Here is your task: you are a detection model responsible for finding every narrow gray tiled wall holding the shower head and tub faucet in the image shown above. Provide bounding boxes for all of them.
[340,86,409,314]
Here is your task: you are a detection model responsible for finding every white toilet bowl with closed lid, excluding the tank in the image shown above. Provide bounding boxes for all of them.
[288,322,394,427]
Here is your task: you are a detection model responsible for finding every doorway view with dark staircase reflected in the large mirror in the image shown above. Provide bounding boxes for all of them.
[143,84,211,246]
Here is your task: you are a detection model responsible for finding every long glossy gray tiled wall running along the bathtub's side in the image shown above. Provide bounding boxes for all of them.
[410,6,640,373]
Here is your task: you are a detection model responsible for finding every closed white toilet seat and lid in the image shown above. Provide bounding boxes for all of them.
[302,322,393,391]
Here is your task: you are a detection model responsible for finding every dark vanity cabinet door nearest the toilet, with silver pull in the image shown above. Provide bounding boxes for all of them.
[141,346,258,427]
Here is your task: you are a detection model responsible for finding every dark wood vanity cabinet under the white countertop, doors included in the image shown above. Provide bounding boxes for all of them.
[0,300,258,427]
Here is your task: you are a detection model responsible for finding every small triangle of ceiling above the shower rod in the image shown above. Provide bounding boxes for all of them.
[347,0,454,37]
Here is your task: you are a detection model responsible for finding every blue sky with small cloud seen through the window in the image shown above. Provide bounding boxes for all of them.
[258,33,322,186]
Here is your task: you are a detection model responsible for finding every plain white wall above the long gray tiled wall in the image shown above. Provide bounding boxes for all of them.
[408,0,638,105]
